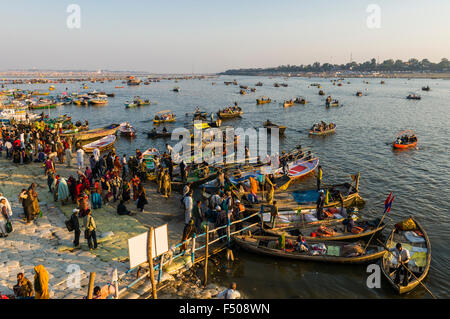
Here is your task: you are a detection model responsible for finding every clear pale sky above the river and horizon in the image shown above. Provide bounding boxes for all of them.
[0,0,450,73]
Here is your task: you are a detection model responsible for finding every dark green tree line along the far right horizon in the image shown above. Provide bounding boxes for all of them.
[219,58,450,75]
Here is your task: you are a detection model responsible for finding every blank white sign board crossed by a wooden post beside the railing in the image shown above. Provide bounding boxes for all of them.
[128,224,169,269]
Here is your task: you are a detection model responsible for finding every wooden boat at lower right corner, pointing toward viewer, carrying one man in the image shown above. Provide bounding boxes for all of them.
[381,217,431,294]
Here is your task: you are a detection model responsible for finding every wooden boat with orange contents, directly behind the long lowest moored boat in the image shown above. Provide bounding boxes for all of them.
[264,218,386,241]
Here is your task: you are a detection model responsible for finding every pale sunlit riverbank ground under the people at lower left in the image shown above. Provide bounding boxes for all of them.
[0,157,227,299]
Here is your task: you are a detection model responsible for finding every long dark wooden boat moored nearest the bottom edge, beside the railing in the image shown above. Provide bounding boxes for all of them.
[233,235,384,264]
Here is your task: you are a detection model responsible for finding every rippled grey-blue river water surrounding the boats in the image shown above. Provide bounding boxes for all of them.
[8,76,450,298]
